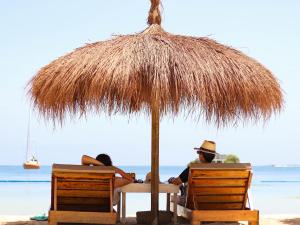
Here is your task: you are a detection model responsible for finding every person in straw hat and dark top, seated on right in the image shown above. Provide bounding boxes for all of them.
[168,140,216,185]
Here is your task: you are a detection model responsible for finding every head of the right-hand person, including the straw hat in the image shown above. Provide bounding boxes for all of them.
[195,140,216,163]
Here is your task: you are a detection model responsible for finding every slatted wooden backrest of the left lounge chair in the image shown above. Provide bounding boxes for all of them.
[51,164,115,212]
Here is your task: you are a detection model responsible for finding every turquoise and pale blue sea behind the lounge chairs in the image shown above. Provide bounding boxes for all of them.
[0,166,300,215]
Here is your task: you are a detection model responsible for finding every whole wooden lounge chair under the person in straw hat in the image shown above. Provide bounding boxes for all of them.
[172,163,259,225]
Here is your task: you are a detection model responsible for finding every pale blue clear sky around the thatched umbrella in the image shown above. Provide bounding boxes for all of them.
[0,0,300,165]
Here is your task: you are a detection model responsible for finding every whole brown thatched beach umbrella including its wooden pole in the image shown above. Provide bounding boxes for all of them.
[30,0,283,223]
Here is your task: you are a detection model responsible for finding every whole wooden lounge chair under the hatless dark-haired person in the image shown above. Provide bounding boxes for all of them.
[49,164,117,225]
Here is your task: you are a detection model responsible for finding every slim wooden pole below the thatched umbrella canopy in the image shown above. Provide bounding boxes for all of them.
[151,103,159,225]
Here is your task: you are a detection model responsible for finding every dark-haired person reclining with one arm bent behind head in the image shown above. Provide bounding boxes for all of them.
[81,154,134,205]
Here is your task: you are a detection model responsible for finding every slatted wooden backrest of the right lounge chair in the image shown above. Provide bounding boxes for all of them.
[186,163,252,210]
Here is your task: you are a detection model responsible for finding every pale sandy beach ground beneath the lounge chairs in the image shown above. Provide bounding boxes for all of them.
[0,214,300,225]
